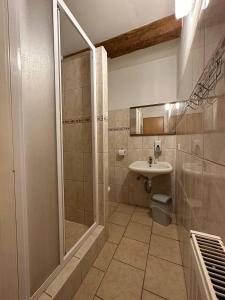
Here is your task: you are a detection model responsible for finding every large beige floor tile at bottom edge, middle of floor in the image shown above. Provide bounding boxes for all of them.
[97,260,144,300]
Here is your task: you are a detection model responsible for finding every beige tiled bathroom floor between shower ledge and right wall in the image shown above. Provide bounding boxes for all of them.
[73,202,187,300]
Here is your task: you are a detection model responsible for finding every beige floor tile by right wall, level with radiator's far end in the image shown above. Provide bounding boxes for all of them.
[149,234,181,265]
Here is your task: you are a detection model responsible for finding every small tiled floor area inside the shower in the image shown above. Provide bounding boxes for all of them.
[65,220,88,252]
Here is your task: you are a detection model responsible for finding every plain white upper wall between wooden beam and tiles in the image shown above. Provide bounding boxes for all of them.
[109,40,179,110]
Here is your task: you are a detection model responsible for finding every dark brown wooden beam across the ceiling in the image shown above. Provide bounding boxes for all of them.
[96,15,182,58]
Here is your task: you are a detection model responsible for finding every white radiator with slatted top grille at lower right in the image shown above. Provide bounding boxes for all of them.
[188,231,225,300]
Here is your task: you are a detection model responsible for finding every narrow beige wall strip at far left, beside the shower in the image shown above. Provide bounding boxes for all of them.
[0,0,18,300]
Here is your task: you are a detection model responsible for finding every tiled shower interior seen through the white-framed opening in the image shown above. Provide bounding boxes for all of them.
[59,4,95,254]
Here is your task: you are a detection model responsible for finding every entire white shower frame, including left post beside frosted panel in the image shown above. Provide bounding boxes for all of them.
[8,0,99,300]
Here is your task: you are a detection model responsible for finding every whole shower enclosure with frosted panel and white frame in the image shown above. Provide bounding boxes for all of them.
[4,0,107,300]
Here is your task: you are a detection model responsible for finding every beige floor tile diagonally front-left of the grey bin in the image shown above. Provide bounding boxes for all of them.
[124,222,151,243]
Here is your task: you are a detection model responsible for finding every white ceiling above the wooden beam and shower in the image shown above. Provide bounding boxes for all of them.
[62,0,175,54]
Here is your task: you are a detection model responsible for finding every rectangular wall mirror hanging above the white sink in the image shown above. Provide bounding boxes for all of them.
[130,102,180,135]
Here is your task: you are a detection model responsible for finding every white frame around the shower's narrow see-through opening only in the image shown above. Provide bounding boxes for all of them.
[53,0,98,260]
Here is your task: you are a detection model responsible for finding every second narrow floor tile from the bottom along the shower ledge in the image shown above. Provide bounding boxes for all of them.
[94,242,117,271]
